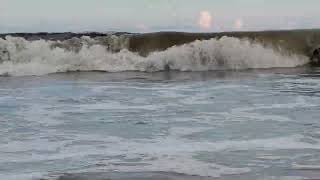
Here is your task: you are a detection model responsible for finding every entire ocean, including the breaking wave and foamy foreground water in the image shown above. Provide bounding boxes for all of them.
[0,31,320,180]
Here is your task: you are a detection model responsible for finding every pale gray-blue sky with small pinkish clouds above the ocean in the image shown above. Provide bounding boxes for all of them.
[0,0,320,33]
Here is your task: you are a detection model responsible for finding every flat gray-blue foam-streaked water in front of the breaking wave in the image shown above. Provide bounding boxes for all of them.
[0,68,320,180]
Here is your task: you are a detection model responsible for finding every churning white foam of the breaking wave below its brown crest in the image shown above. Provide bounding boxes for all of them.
[0,36,309,76]
